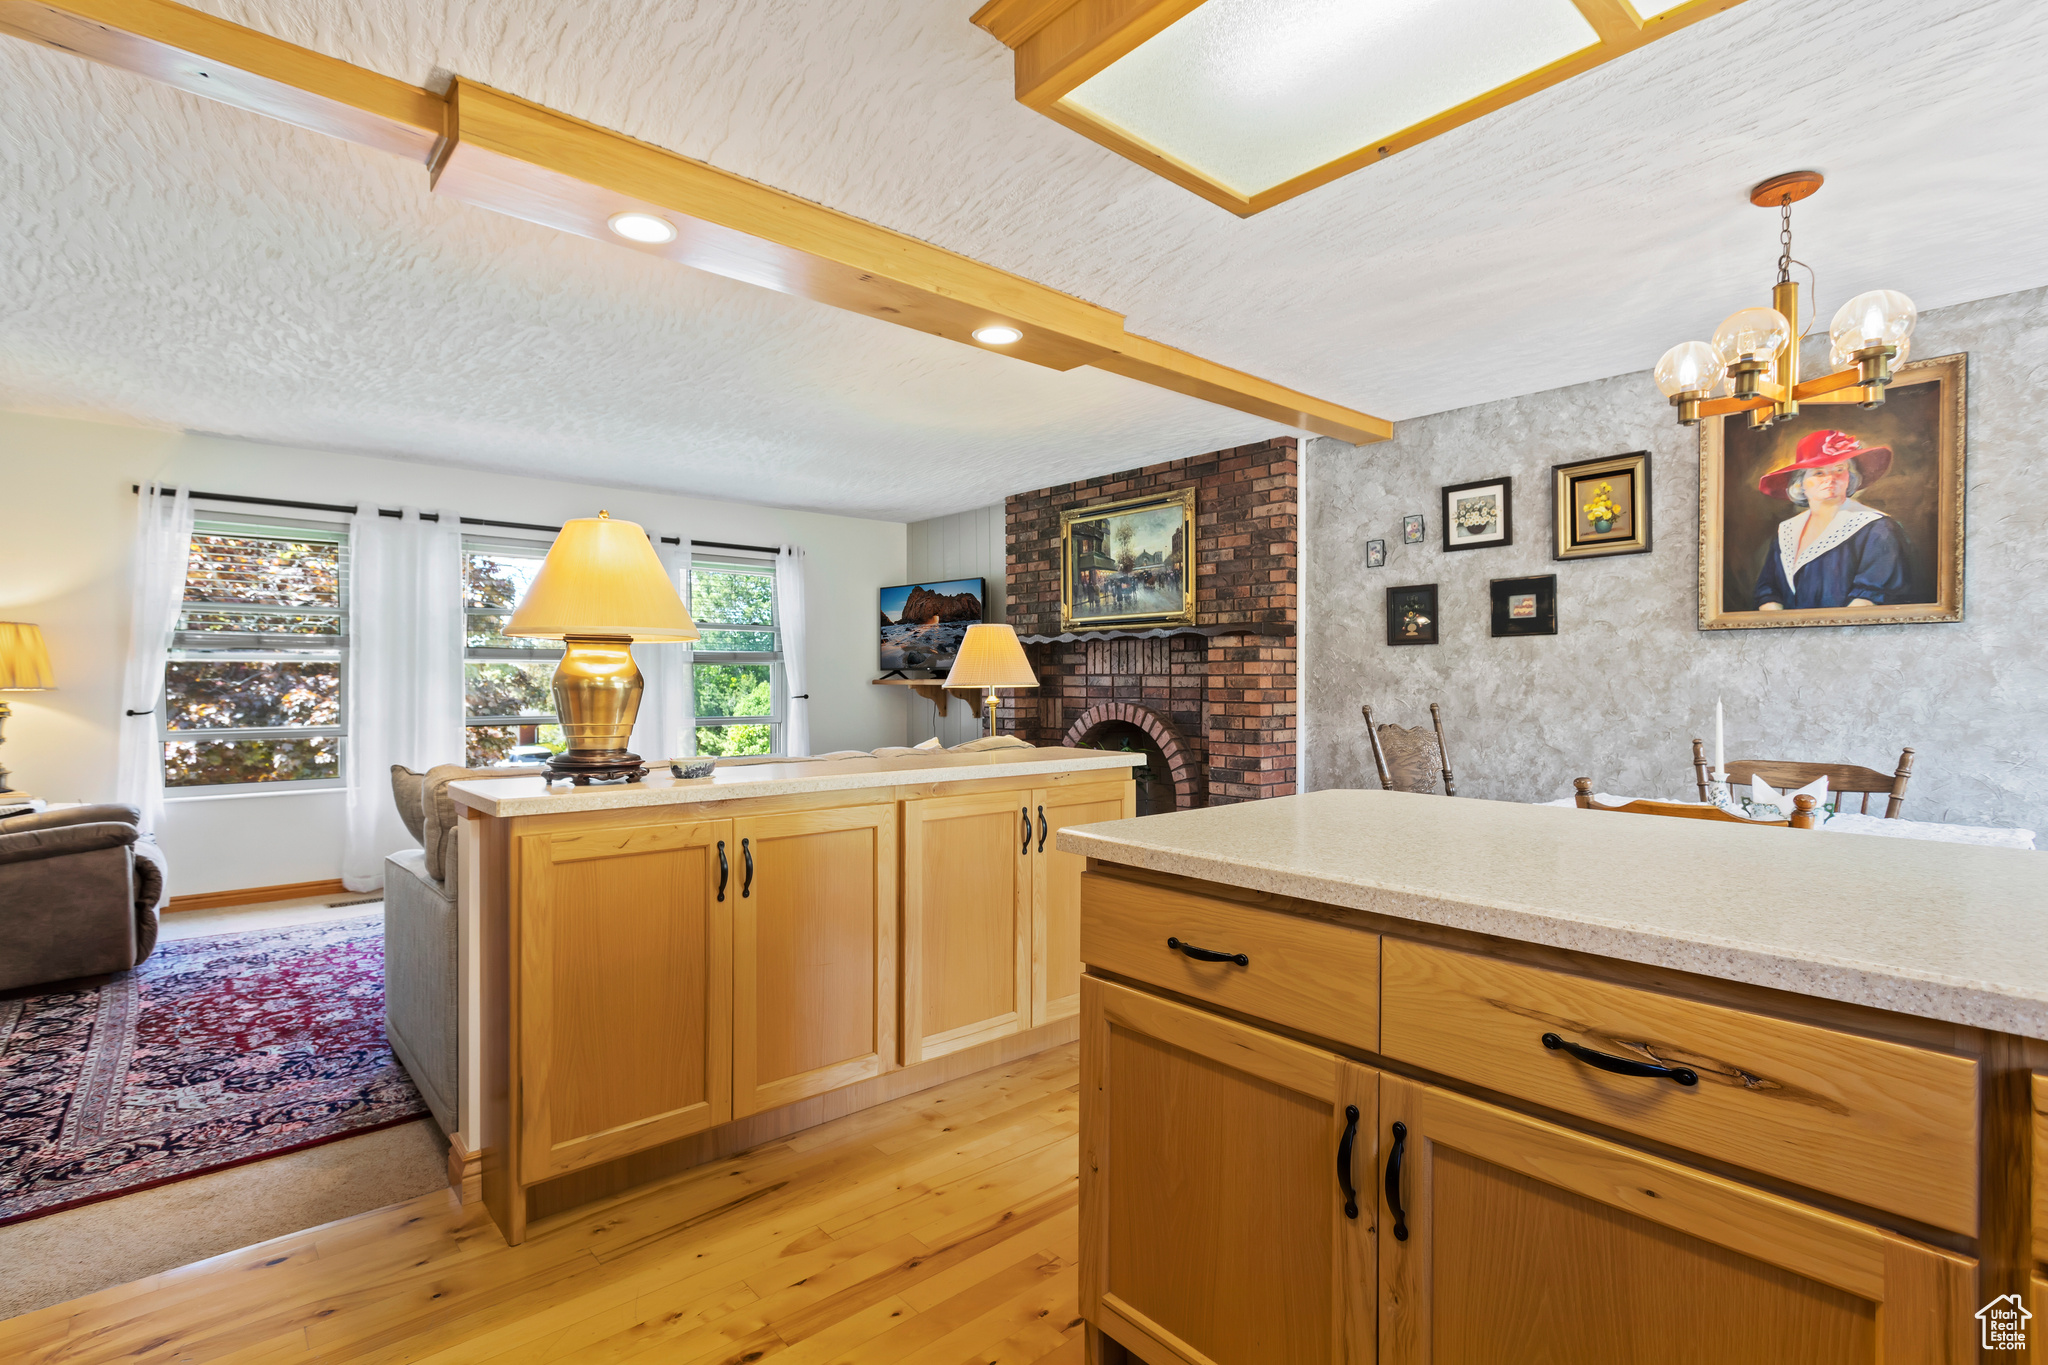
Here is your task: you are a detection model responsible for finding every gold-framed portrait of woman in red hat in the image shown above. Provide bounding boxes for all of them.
[1700,356,1968,630]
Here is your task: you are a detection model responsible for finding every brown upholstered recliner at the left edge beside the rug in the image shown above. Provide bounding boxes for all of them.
[0,806,164,990]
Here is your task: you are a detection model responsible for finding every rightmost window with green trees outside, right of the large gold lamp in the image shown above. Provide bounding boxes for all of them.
[690,555,782,757]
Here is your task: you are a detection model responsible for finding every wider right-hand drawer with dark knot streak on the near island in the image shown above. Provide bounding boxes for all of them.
[1380,937,1976,1236]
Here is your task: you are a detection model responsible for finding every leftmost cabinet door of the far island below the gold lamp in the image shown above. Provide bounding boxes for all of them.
[518,821,737,1185]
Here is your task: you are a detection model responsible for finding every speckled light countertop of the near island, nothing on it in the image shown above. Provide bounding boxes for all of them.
[1059,792,2048,1040]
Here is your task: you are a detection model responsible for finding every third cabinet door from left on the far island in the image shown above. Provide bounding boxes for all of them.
[903,792,1036,1066]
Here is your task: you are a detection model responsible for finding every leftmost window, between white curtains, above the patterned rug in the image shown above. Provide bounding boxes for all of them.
[160,512,348,790]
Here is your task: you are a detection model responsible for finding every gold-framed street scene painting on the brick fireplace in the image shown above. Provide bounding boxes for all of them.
[1059,489,1194,630]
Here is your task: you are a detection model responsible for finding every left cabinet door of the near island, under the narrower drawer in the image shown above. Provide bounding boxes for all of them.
[1081,976,1378,1365]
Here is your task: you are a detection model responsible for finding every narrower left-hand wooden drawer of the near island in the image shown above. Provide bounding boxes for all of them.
[1081,872,1380,1050]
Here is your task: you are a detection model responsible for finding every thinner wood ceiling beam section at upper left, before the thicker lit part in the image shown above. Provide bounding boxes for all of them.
[0,0,446,164]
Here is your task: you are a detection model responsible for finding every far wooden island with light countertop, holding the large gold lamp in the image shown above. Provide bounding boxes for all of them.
[449,747,1143,1244]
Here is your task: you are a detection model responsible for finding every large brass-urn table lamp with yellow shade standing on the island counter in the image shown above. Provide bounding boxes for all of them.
[506,512,696,786]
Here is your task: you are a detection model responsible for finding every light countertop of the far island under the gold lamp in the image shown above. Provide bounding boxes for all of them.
[449,745,1145,817]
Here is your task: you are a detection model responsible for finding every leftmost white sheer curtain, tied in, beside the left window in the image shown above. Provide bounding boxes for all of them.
[115,483,193,831]
